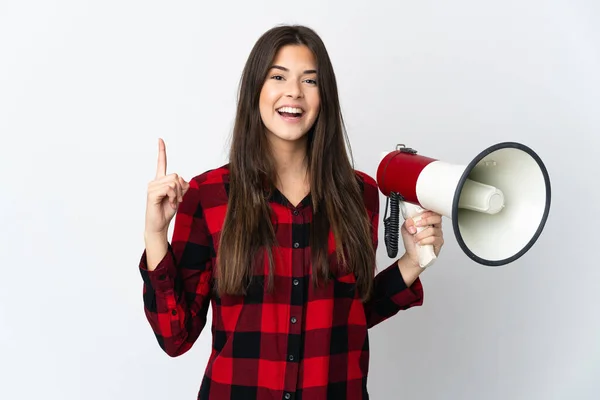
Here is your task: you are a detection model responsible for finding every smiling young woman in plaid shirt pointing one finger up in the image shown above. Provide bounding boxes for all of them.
[140,26,443,400]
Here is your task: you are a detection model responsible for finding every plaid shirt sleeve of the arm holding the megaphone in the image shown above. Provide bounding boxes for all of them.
[363,174,423,328]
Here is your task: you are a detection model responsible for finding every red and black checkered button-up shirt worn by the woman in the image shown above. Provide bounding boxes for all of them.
[140,166,423,400]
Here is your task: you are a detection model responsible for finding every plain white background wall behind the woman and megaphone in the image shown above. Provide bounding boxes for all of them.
[0,0,600,400]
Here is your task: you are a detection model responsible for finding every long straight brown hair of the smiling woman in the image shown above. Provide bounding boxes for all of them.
[215,25,375,299]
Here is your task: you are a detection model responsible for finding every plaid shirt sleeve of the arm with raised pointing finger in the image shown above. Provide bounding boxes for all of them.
[139,180,213,357]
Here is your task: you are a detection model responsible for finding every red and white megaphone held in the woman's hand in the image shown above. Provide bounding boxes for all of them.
[377,142,551,268]
